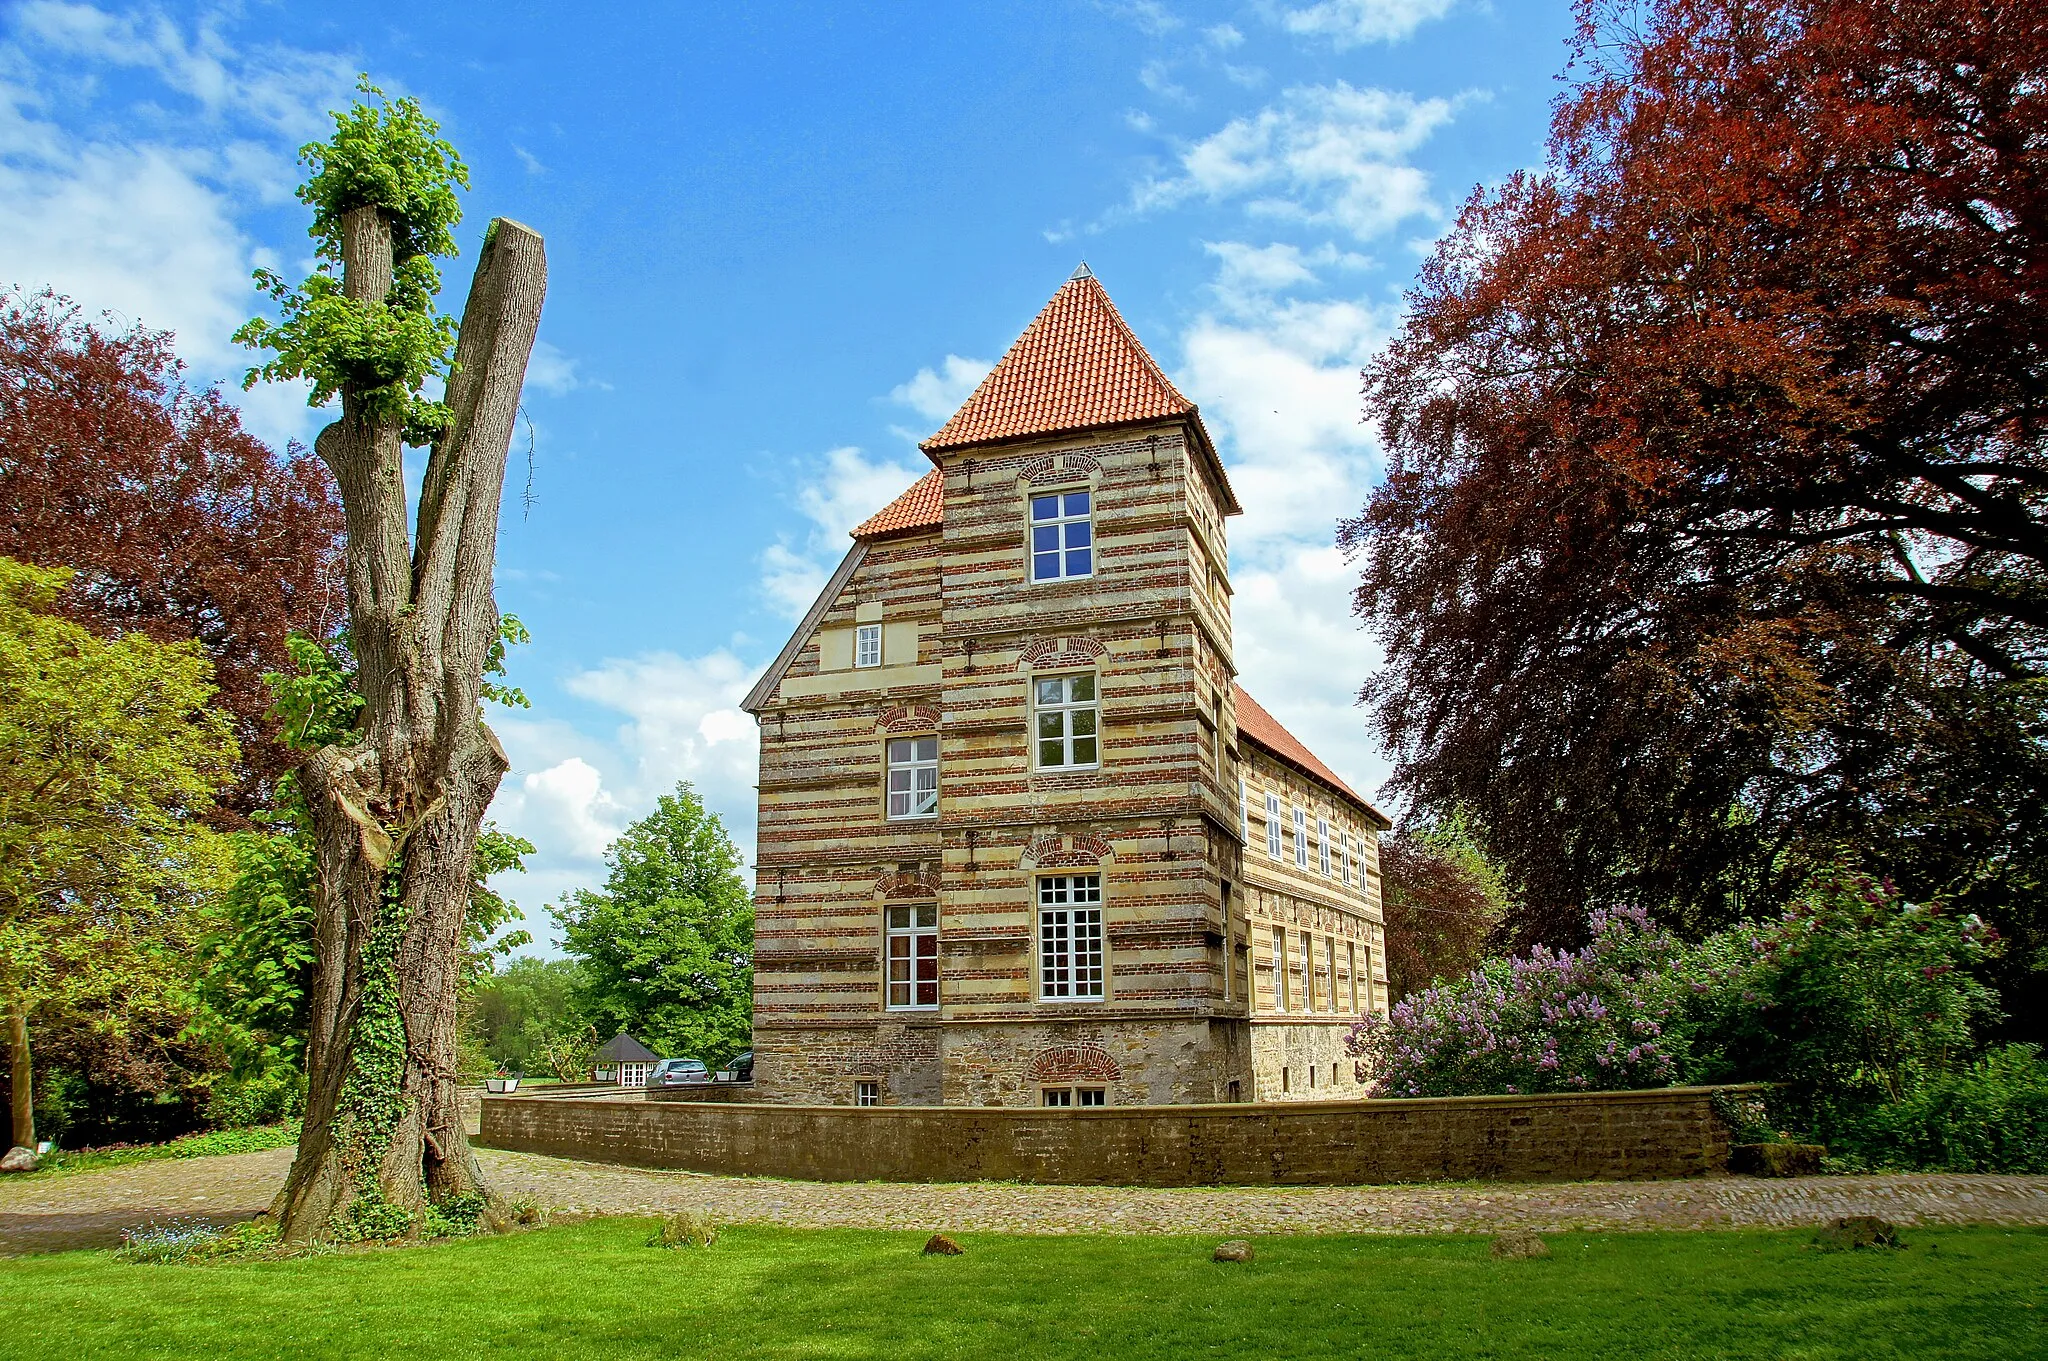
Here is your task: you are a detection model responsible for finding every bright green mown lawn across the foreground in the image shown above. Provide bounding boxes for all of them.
[0,1220,2048,1361]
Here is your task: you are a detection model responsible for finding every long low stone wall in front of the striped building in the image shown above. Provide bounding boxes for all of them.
[479,1087,1729,1187]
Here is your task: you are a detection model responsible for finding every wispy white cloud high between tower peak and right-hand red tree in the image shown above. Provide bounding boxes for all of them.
[1130,80,1456,239]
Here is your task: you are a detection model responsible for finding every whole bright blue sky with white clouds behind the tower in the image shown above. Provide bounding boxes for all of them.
[0,0,1571,939]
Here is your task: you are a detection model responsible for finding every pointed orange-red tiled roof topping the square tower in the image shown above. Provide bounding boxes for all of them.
[920,266,1194,454]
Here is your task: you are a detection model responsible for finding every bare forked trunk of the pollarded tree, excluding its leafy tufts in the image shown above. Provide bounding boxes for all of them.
[272,207,547,1242]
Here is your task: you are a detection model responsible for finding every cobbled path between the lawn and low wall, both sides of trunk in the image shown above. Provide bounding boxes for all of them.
[0,1148,2048,1255]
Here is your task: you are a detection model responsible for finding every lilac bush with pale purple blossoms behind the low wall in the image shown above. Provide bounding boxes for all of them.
[1348,909,1686,1097]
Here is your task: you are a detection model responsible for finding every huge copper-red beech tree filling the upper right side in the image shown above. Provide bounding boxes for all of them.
[1343,0,2048,1009]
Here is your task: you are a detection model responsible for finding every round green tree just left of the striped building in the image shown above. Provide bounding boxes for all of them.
[549,784,754,1064]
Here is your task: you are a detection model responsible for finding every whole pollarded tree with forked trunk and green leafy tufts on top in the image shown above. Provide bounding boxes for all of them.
[238,82,547,1240]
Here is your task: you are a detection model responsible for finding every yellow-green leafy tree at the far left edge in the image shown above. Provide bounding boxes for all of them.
[0,559,238,1144]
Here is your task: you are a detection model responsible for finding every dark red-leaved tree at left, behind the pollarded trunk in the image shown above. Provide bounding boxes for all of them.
[0,291,342,810]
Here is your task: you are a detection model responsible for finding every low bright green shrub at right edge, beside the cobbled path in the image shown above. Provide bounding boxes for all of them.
[1825,1044,2048,1173]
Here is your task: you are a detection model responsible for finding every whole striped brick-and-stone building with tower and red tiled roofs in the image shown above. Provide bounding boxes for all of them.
[748,270,1386,1105]
